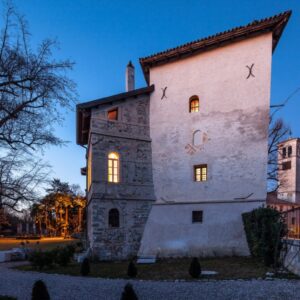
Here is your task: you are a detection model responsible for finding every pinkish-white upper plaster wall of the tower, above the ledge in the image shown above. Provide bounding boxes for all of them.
[150,33,272,204]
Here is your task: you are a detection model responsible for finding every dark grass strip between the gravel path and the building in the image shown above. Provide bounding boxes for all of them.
[18,257,298,280]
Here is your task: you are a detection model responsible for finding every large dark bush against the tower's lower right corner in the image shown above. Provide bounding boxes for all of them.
[242,207,287,266]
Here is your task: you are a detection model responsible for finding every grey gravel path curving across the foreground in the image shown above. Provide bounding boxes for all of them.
[0,264,300,300]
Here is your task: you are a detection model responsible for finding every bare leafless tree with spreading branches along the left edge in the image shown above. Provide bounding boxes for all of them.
[0,6,76,210]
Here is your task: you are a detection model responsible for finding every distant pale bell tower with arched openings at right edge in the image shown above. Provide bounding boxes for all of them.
[277,138,300,203]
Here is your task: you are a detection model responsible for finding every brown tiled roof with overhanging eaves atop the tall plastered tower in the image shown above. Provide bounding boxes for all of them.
[140,11,292,83]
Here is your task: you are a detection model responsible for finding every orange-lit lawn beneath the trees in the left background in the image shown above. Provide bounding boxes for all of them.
[0,238,77,251]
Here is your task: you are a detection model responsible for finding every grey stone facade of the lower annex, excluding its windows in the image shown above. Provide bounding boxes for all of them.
[88,95,154,260]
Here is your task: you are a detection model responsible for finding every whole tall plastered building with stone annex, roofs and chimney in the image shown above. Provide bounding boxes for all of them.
[77,12,290,259]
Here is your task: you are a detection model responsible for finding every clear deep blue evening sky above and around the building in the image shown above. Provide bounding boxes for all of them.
[8,0,300,188]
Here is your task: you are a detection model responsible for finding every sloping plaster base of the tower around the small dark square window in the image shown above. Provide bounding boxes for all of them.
[138,201,262,257]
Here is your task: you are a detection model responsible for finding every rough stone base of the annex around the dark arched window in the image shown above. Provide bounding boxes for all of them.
[90,199,152,260]
